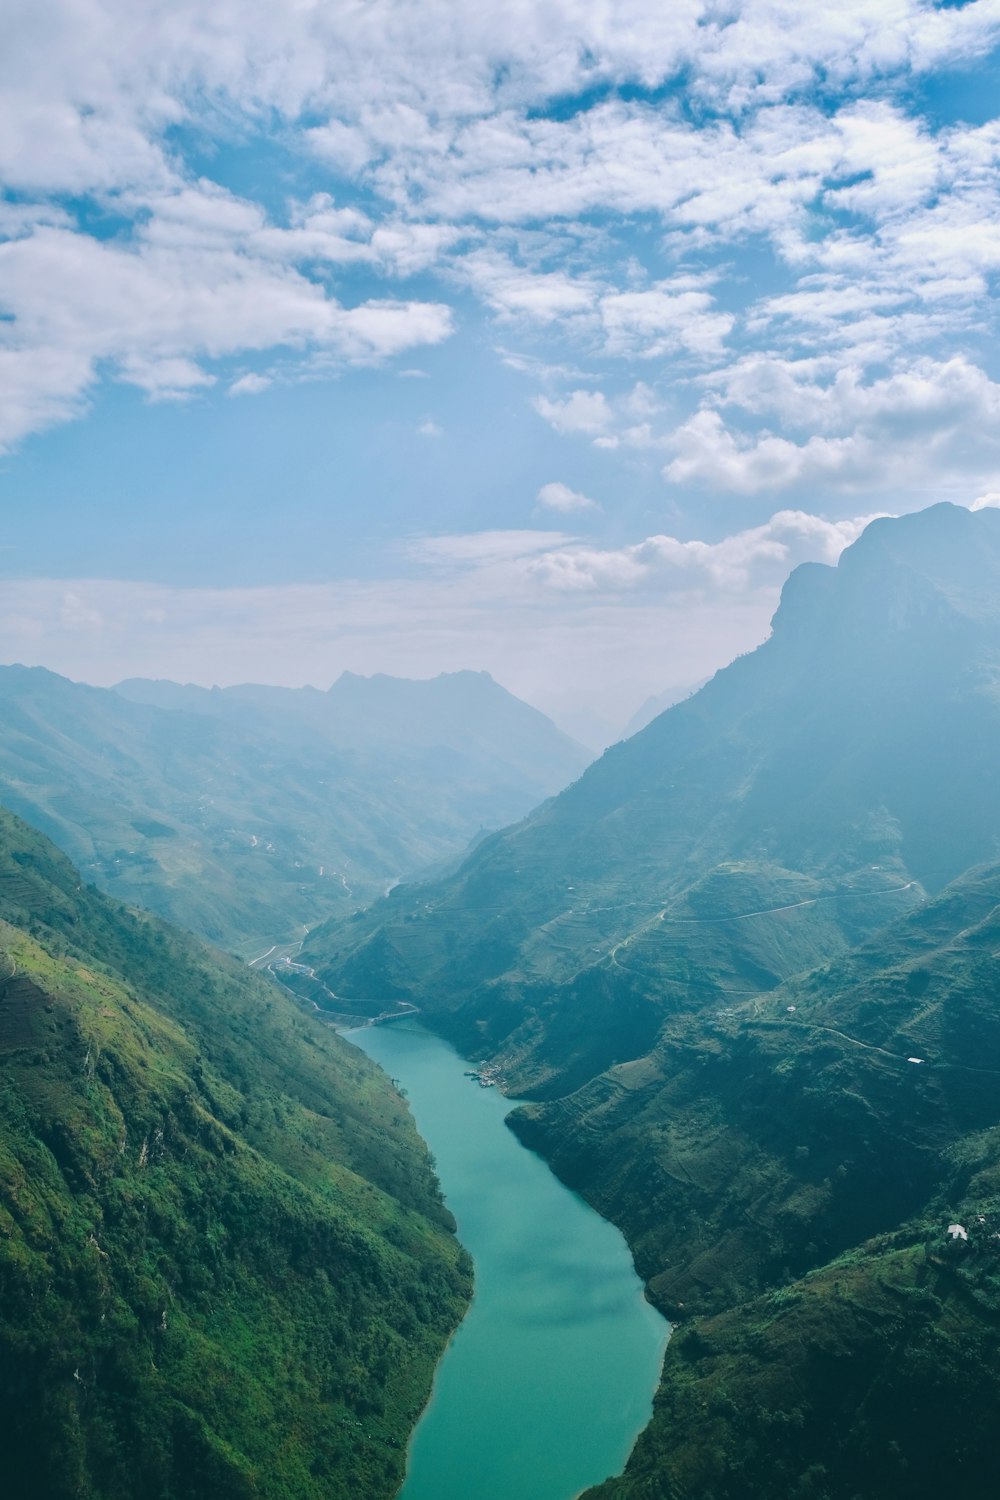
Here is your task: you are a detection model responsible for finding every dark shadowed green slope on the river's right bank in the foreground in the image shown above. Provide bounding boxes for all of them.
[575,866,1000,1500]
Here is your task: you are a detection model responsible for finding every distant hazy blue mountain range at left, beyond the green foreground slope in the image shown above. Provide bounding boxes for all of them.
[0,666,588,953]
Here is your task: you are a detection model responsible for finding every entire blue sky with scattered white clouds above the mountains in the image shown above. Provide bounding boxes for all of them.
[0,0,1000,743]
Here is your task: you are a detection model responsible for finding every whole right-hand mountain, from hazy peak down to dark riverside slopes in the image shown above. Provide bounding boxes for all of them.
[306,506,1000,1500]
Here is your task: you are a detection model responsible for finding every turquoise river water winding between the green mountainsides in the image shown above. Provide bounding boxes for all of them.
[348,1022,667,1500]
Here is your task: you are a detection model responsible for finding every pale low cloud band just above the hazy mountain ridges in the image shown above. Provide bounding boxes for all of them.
[0,512,881,722]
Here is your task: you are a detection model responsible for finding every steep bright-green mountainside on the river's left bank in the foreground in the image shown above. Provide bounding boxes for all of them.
[0,813,469,1500]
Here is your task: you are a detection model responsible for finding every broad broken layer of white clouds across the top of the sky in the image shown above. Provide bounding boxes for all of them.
[0,0,1000,513]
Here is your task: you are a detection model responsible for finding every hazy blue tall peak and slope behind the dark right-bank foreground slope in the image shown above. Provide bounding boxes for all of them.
[310,506,1000,1091]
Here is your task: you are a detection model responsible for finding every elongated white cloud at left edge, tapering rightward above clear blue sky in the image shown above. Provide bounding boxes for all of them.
[0,227,451,444]
